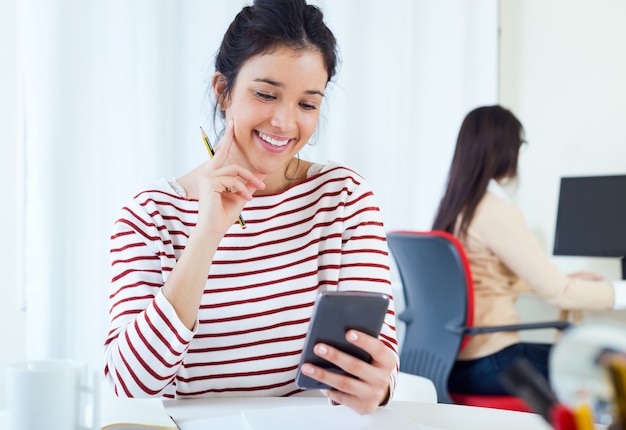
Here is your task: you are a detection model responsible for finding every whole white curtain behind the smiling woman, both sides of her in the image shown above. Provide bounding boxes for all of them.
[18,0,498,376]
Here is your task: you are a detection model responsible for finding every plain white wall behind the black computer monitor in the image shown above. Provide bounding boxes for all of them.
[500,0,626,336]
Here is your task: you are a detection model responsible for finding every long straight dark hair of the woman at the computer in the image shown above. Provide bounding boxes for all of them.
[433,105,524,237]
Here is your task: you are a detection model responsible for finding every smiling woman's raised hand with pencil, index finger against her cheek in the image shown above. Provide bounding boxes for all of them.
[196,121,265,234]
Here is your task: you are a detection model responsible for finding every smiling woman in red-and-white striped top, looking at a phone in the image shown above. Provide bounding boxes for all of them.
[105,0,398,413]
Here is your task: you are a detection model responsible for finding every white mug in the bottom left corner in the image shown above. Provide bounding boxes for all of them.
[6,360,100,430]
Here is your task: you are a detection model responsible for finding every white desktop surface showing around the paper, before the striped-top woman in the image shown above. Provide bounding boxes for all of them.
[163,397,551,430]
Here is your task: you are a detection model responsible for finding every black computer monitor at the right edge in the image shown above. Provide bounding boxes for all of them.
[554,175,626,279]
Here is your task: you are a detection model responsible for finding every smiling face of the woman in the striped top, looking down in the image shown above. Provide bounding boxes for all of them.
[214,47,328,175]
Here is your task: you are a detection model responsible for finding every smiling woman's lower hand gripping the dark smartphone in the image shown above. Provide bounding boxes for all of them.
[302,330,396,415]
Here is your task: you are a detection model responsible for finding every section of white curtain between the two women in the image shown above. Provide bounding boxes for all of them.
[303,0,498,229]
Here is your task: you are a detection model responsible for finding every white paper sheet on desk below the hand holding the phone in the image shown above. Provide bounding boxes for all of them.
[242,405,440,430]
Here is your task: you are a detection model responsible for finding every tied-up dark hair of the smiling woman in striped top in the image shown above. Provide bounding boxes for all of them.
[215,0,337,119]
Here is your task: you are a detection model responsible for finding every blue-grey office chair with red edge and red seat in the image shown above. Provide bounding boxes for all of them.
[387,231,570,412]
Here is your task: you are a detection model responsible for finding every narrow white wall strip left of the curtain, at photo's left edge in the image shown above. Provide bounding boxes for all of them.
[0,0,25,409]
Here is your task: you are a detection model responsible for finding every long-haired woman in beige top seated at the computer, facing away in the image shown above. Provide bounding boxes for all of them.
[433,105,626,395]
